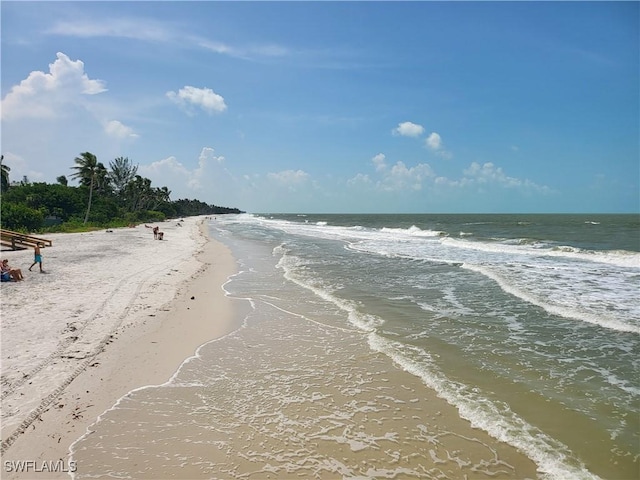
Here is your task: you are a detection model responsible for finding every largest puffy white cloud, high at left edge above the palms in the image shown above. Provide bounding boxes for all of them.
[2,52,106,120]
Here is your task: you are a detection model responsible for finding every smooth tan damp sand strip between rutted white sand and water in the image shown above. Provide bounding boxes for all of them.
[2,220,238,479]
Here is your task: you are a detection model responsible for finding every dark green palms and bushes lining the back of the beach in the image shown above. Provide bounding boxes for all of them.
[0,152,244,232]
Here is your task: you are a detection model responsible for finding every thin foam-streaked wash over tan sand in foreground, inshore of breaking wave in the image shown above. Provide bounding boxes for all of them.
[73,286,537,479]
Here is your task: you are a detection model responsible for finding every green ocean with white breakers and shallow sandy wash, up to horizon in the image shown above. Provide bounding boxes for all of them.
[74,214,640,480]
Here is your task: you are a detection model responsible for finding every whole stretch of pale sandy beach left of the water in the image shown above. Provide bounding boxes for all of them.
[0,217,236,479]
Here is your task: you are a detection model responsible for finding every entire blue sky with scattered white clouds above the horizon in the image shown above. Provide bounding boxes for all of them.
[0,0,640,213]
